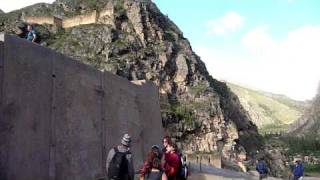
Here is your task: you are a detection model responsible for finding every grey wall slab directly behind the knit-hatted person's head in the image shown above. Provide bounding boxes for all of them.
[104,72,143,167]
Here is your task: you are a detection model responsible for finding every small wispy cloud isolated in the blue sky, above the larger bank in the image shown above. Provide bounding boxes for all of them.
[206,11,244,35]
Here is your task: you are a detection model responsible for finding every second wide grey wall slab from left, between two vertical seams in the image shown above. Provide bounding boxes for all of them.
[52,54,103,180]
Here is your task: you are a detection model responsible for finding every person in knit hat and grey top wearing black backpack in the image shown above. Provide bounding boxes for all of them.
[106,134,134,180]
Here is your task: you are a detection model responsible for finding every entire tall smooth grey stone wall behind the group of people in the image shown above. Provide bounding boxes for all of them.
[0,35,163,180]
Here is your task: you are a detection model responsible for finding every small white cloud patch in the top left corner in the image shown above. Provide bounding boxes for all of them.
[0,0,55,12]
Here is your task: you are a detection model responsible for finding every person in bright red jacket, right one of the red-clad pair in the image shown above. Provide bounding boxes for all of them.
[164,143,180,180]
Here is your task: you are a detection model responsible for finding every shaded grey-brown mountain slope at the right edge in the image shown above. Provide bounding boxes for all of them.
[289,86,320,134]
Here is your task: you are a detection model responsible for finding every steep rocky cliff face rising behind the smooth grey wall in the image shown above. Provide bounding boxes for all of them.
[0,0,261,159]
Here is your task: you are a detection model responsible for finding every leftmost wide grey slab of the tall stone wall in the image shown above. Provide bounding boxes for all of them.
[0,36,54,180]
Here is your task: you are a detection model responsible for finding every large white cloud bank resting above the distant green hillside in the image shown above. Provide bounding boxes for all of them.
[195,25,320,100]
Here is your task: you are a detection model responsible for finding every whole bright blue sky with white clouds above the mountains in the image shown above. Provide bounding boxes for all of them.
[0,0,320,100]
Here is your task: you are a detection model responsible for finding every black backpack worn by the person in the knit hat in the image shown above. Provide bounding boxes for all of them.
[108,147,131,180]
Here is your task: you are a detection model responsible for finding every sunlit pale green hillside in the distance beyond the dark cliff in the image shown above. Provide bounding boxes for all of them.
[228,83,305,131]
